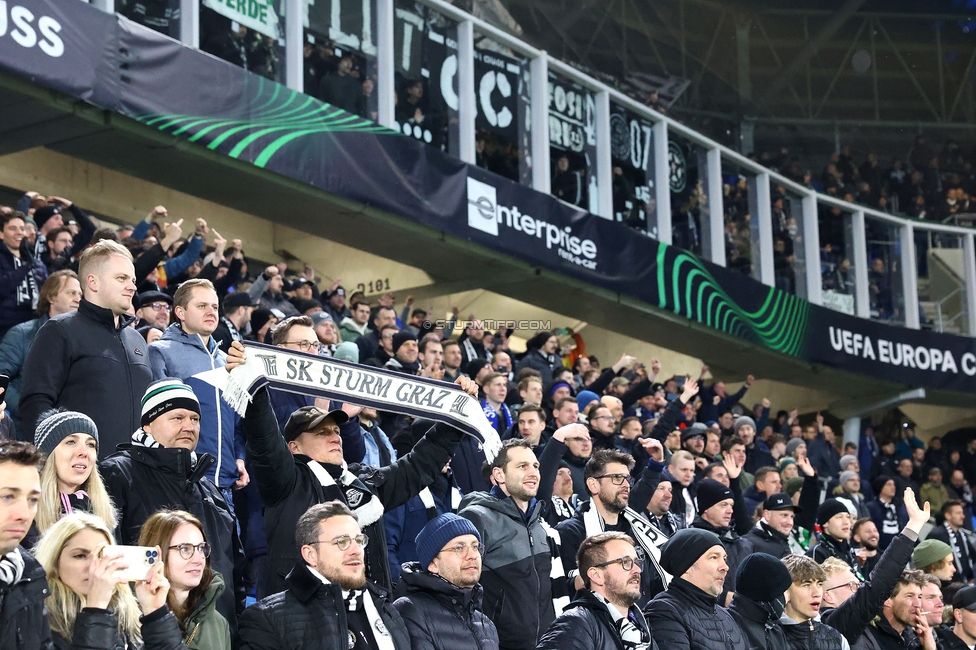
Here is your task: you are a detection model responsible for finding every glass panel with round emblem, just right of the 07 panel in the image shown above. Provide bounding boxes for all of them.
[668,133,709,257]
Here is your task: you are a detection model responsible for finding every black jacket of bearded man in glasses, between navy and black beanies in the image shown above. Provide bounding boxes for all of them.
[536,589,667,650]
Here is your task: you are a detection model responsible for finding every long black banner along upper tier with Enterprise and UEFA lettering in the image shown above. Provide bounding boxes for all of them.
[0,0,976,392]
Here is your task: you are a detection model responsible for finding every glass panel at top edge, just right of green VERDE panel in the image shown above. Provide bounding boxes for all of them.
[302,0,379,120]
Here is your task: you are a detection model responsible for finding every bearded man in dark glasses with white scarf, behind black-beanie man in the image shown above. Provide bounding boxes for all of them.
[556,448,664,607]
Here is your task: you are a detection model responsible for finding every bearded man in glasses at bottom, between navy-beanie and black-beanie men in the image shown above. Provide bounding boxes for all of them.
[537,532,668,650]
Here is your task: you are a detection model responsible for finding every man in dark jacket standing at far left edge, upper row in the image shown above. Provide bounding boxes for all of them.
[0,211,47,337]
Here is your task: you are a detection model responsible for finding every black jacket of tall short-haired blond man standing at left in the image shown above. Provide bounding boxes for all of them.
[20,299,152,459]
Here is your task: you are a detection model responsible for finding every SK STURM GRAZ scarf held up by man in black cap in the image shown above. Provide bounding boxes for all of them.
[201,342,502,462]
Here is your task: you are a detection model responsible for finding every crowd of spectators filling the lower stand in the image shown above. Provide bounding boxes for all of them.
[0,192,976,650]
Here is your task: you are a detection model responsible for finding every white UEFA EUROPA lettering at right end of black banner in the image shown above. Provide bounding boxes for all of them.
[830,326,964,377]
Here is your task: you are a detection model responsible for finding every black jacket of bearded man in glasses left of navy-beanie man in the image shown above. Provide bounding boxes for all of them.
[240,561,411,650]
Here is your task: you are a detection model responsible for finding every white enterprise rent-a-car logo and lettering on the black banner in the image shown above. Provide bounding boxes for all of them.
[468,178,597,270]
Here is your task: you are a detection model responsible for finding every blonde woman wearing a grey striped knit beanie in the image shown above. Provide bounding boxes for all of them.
[25,410,116,546]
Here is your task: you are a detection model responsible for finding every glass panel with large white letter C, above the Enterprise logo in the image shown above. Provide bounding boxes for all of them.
[474,32,532,186]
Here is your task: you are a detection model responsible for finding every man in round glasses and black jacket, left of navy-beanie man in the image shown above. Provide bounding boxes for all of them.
[246,501,411,650]
